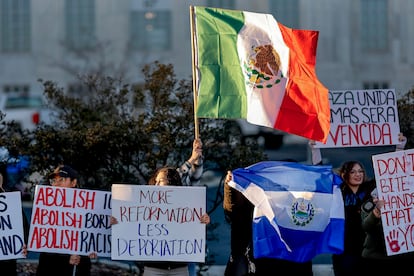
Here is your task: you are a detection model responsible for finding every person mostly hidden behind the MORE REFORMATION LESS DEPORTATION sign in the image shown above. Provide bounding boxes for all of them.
[143,167,210,276]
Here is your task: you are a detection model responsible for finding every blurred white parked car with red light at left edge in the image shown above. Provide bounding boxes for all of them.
[0,94,53,130]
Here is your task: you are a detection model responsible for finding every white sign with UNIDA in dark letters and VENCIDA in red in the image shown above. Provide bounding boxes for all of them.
[316,89,400,148]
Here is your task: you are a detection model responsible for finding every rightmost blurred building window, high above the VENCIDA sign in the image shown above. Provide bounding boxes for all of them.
[360,0,388,51]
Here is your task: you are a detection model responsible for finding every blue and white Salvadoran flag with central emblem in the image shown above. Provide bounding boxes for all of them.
[229,161,345,262]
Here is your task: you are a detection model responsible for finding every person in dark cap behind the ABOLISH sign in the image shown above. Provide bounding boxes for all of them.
[36,165,97,276]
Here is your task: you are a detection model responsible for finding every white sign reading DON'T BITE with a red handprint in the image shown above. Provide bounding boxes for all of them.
[372,149,414,255]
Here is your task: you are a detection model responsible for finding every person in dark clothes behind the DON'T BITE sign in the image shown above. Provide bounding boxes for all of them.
[361,134,414,276]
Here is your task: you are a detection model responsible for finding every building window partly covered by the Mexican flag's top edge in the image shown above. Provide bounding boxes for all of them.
[270,0,299,29]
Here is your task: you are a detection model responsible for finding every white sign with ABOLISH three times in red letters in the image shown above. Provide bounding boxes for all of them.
[29,185,111,257]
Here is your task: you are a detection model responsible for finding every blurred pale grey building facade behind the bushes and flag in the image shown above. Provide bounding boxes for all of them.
[0,0,414,98]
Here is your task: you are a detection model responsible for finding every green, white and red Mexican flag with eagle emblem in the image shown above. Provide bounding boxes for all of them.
[192,7,330,143]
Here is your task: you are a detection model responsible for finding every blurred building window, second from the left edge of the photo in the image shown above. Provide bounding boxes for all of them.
[65,0,95,50]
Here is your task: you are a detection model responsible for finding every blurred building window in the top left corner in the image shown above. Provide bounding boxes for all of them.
[0,0,31,52]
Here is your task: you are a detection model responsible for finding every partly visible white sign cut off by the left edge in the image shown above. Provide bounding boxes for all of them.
[0,192,25,260]
